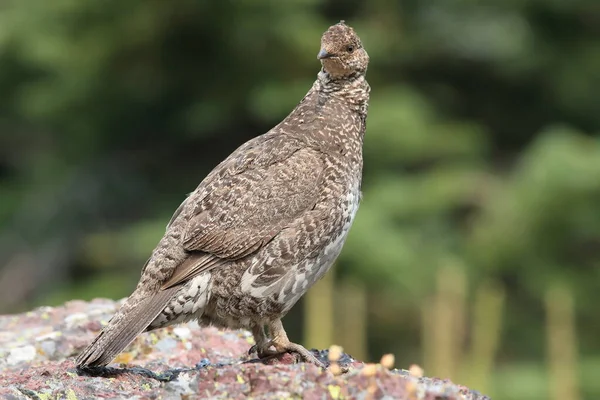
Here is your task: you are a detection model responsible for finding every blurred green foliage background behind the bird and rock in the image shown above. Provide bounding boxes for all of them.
[0,0,600,400]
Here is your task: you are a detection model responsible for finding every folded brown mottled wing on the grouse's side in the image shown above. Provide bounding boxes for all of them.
[162,136,325,289]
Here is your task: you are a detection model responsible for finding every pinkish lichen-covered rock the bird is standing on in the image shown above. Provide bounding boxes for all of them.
[0,300,489,400]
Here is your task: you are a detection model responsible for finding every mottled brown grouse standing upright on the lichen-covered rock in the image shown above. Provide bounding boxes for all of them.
[76,20,371,369]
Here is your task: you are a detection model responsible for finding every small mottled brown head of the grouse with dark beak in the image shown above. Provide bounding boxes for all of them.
[317,21,369,79]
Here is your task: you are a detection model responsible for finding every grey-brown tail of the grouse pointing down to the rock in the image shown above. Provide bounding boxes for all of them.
[76,286,180,368]
